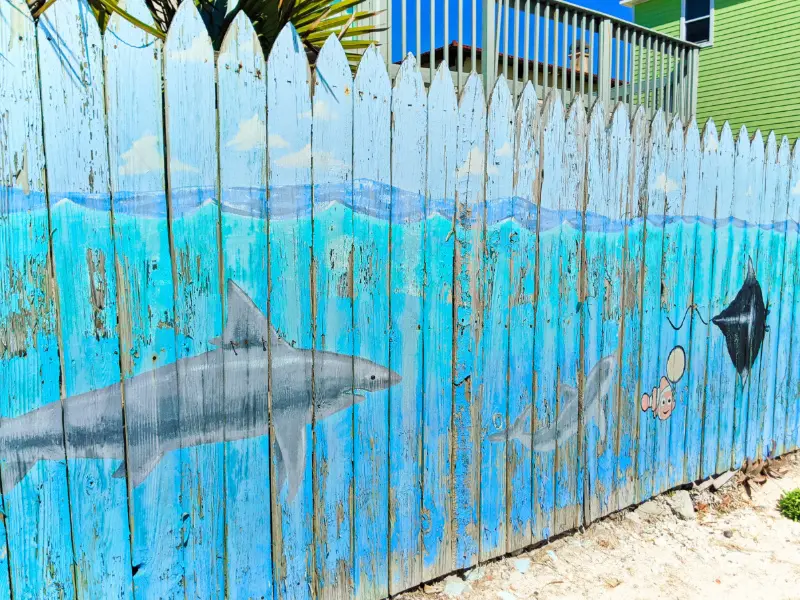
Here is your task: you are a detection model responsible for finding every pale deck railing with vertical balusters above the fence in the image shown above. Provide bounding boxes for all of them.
[368,0,699,119]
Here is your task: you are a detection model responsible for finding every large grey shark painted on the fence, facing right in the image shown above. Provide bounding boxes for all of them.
[0,280,400,499]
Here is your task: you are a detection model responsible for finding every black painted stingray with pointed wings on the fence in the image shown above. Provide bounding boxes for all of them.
[711,259,768,379]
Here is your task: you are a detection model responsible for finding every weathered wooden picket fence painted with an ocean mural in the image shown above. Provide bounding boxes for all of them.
[0,0,800,600]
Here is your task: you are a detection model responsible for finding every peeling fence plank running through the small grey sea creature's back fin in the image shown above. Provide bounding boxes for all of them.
[553,96,591,534]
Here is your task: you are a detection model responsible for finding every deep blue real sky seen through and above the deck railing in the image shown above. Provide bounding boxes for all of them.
[392,0,633,61]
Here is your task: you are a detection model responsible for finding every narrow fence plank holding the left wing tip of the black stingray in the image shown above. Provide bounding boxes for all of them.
[703,122,737,474]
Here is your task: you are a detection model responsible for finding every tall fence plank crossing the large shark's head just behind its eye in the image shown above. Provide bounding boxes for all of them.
[311,34,354,599]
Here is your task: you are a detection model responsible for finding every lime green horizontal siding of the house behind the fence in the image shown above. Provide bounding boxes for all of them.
[634,0,800,139]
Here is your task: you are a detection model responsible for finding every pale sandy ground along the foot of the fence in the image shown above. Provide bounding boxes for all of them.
[401,453,800,600]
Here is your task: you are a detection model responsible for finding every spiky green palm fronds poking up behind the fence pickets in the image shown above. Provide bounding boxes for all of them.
[28,0,386,63]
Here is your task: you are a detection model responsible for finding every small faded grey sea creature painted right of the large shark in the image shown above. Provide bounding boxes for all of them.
[489,356,615,452]
